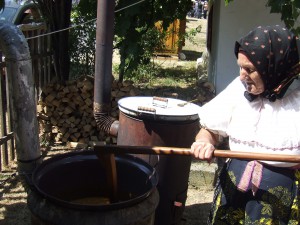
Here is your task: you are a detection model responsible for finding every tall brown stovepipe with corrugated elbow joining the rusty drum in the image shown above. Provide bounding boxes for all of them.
[94,0,119,136]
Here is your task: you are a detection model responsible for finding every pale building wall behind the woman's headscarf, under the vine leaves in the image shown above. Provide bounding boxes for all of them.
[208,0,284,94]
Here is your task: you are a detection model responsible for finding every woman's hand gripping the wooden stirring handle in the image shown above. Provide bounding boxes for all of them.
[191,141,215,163]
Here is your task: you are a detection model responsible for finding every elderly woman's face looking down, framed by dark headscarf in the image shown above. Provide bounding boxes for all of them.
[237,52,265,95]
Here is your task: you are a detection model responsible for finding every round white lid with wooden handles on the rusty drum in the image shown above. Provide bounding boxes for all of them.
[118,96,201,121]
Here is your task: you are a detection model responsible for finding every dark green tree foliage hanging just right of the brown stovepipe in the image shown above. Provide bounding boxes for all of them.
[115,0,192,80]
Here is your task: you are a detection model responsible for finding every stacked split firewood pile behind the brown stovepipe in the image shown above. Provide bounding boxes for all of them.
[37,76,138,146]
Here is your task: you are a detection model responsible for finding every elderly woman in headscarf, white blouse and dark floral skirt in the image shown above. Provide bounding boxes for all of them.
[191,26,300,224]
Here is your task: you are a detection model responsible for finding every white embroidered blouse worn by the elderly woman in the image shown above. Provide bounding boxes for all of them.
[199,77,300,167]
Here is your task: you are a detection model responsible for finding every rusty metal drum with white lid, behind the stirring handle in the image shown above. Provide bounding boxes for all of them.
[117,96,200,225]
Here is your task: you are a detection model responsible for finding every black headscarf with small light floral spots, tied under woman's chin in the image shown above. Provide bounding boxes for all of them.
[235,25,300,102]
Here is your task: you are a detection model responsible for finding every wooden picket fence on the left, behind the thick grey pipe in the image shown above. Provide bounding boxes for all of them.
[0,23,55,172]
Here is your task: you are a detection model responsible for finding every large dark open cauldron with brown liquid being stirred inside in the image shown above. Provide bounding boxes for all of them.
[28,151,159,225]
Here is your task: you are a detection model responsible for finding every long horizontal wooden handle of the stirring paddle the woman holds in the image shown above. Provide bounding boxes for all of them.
[94,145,300,163]
